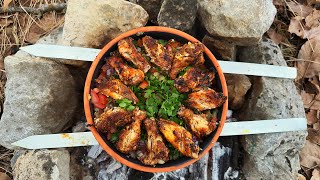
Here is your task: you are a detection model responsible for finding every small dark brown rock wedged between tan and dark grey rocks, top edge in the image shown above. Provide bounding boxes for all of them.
[129,0,162,23]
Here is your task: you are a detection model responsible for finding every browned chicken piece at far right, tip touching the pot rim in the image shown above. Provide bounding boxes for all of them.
[186,88,227,111]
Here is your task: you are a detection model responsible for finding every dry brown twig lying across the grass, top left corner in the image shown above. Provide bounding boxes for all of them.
[0,3,67,17]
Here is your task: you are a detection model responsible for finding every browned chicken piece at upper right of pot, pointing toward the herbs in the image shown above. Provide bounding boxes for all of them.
[169,42,204,79]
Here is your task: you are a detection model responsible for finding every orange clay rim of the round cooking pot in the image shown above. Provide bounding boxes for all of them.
[83,26,228,172]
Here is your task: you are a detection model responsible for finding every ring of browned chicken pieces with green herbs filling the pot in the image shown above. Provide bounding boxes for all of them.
[90,36,227,166]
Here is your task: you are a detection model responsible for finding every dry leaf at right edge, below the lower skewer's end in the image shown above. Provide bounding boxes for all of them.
[300,140,320,168]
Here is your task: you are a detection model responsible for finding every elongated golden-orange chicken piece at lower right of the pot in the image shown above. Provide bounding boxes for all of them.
[158,119,200,158]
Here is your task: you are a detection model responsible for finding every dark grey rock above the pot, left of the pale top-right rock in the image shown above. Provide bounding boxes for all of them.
[158,0,197,31]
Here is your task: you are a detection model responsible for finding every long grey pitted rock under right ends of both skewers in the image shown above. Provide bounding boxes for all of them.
[239,39,306,179]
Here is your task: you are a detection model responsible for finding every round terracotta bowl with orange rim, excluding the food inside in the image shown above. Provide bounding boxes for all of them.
[83,26,228,172]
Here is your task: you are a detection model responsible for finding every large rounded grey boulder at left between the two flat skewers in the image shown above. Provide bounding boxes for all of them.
[0,51,78,148]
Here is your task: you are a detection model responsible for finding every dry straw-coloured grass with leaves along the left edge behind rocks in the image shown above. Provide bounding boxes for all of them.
[0,0,66,177]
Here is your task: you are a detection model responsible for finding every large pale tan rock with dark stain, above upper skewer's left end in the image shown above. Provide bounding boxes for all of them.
[63,0,148,48]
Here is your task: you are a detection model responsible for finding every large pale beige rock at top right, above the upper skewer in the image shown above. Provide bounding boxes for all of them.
[198,0,276,45]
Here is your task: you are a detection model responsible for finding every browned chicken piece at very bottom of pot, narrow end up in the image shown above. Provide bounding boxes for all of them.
[139,118,169,165]
